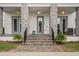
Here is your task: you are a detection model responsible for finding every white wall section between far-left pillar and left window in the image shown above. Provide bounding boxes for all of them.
[3,12,12,34]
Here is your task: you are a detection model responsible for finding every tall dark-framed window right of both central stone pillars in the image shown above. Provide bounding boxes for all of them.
[58,16,68,34]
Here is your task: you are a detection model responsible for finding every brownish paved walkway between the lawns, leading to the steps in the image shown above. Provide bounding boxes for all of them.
[9,45,63,52]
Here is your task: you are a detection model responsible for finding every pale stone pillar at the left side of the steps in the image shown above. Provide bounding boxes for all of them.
[21,3,29,39]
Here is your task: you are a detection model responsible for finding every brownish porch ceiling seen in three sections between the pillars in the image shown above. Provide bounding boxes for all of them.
[3,7,76,15]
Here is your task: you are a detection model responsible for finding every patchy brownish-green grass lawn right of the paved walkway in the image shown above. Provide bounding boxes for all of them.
[59,43,79,52]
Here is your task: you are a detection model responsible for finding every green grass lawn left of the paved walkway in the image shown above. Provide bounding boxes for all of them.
[0,42,17,52]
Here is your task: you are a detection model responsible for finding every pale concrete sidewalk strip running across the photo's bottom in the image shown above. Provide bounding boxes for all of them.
[0,52,79,56]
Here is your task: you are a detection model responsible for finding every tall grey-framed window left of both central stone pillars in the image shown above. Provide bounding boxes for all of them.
[12,16,21,34]
